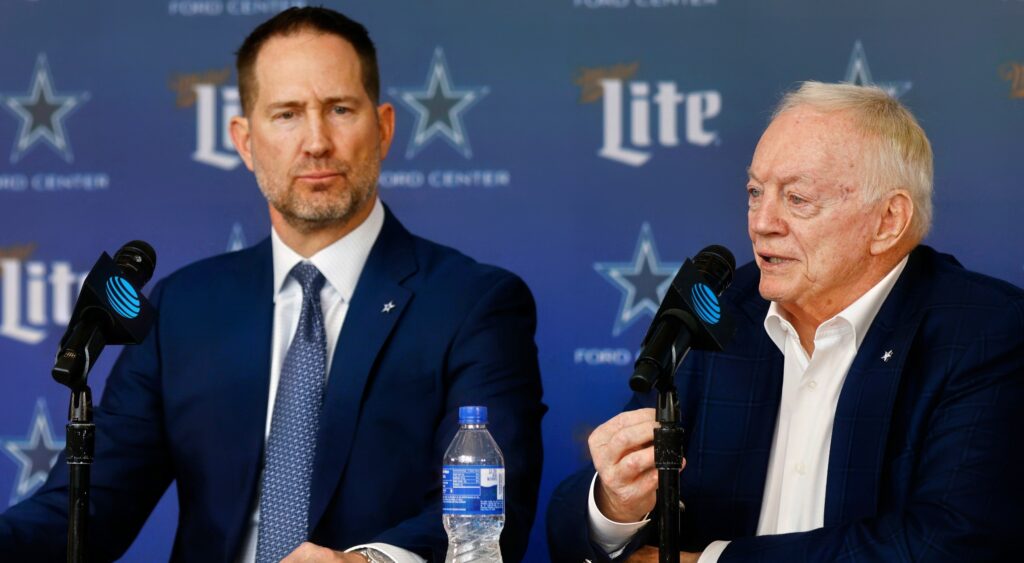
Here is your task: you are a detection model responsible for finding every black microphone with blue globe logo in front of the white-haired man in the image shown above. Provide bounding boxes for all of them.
[630,245,736,393]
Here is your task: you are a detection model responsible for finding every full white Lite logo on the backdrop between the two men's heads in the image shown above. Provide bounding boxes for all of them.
[575,62,722,166]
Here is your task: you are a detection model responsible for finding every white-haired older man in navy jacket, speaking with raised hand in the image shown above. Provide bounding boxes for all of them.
[548,83,1024,563]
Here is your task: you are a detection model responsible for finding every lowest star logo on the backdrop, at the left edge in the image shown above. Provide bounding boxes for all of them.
[0,397,65,505]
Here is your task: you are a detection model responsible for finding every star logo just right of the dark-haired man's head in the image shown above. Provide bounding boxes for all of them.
[388,47,489,159]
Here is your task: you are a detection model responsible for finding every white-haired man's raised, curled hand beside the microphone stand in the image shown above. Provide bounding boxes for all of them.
[587,408,685,522]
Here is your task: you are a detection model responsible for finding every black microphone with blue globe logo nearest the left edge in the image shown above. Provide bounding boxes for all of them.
[51,241,157,390]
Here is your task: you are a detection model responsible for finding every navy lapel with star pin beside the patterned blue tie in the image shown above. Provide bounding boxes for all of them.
[309,210,417,530]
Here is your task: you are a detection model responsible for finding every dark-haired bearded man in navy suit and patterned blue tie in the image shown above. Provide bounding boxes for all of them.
[0,8,545,562]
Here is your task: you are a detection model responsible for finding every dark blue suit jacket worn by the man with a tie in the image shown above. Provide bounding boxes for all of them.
[0,212,545,562]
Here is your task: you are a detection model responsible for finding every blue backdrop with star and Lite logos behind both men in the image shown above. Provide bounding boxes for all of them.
[0,0,1024,561]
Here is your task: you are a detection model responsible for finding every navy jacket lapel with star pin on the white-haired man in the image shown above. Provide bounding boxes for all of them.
[824,247,930,526]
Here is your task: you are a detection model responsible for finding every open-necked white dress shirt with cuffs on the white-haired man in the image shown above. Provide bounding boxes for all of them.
[589,258,907,563]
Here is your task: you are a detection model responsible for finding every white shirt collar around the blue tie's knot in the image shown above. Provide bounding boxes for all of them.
[270,198,384,302]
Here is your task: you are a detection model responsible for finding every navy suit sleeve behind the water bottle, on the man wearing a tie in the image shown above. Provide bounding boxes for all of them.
[373,272,547,561]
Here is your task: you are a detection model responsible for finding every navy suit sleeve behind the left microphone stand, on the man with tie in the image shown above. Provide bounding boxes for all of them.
[0,286,171,561]
